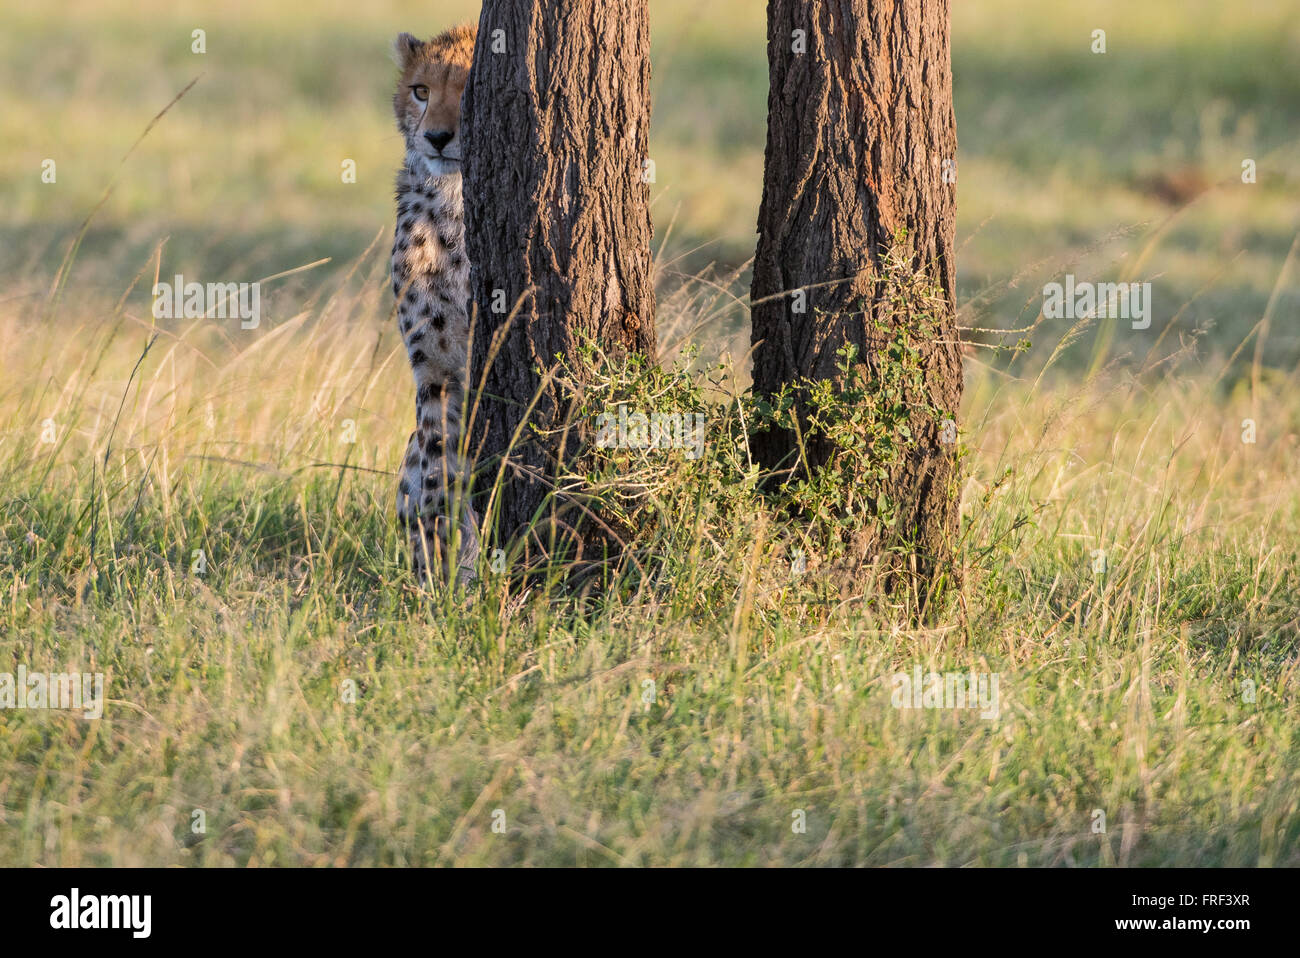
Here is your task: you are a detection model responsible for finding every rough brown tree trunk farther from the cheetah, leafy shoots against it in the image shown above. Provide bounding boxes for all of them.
[751,0,962,590]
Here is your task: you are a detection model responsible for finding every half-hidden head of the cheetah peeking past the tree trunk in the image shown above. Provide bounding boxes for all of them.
[393,25,477,177]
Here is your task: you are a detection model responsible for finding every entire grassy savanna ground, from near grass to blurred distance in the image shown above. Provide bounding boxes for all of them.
[0,0,1300,866]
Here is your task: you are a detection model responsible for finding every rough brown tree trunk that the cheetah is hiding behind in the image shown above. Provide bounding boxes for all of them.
[463,0,655,556]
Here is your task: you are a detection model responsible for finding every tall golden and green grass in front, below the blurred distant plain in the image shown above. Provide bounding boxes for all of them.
[0,222,1300,866]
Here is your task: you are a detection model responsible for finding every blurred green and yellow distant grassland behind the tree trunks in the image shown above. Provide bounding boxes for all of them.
[0,0,1300,369]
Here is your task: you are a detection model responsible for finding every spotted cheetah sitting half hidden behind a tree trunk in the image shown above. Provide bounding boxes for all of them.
[393,25,478,582]
